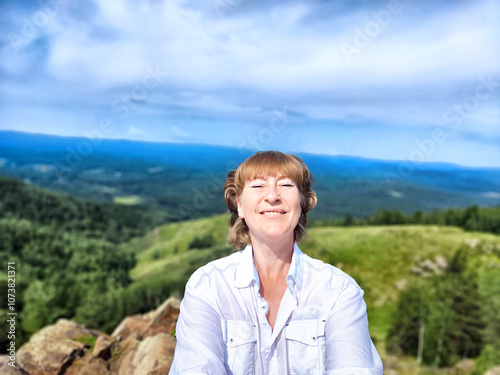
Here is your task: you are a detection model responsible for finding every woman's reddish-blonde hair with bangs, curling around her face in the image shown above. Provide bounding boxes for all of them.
[224,151,317,248]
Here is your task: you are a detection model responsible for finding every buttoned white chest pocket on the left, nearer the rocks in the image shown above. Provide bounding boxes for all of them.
[221,320,257,375]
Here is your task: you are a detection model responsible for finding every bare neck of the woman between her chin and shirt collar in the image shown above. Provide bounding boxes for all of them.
[251,234,294,280]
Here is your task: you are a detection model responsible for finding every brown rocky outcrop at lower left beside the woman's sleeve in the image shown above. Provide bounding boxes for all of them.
[10,299,179,375]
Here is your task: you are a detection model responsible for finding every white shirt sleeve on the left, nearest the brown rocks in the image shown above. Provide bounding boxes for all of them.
[169,274,226,375]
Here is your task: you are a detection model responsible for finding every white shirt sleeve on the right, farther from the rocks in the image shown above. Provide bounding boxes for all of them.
[325,280,383,375]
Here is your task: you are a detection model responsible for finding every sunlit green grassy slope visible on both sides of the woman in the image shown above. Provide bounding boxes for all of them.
[126,215,500,362]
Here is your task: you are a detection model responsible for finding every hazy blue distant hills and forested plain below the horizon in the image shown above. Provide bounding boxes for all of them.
[0,131,500,219]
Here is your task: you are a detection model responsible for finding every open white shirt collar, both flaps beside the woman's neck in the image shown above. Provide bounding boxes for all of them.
[234,242,304,297]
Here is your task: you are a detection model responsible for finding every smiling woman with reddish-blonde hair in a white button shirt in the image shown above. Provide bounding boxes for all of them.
[170,151,382,375]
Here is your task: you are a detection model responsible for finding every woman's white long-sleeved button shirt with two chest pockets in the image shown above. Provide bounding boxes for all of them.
[170,244,382,375]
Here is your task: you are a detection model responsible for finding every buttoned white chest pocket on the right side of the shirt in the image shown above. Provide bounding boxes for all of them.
[286,319,326,374]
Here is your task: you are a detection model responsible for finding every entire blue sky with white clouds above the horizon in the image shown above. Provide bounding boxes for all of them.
[0,0,500,167]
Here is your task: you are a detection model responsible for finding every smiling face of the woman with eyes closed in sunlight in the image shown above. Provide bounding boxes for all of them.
[238,175,302,245]
